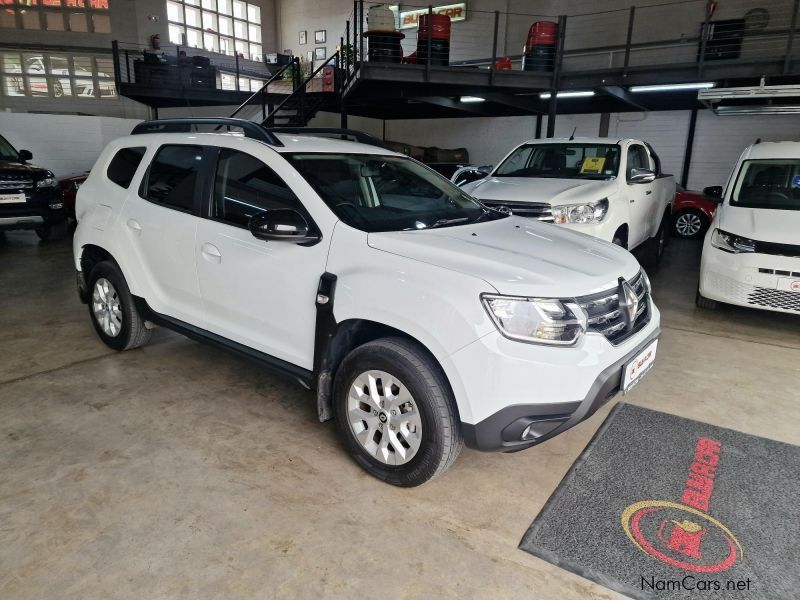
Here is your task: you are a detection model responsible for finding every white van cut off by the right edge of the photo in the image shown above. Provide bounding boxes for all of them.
[697,142,800,314]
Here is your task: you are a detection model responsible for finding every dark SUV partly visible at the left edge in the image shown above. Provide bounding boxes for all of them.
[0,135,66,240]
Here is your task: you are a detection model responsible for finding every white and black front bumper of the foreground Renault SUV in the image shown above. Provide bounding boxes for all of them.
[452,302,660,452]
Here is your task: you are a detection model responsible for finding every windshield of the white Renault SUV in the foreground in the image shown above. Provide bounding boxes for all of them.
[283,153,502,232]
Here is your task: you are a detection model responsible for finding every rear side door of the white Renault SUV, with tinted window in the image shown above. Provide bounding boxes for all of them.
[120,144,208,327]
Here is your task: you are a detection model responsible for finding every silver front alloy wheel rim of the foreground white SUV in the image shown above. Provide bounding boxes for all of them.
[347,370,422,466]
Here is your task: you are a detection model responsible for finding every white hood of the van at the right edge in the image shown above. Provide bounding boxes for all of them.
[718,204,800,245]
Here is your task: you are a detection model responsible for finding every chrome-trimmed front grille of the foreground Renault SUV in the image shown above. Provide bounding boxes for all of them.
[577,271,650,346]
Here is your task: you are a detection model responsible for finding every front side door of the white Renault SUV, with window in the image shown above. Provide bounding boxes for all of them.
[196,148,330,370]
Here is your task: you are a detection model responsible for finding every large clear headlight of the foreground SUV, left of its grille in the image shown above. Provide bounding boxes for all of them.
[481,294,587,346]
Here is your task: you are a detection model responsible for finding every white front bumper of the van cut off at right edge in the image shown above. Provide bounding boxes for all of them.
[699,243,800,315]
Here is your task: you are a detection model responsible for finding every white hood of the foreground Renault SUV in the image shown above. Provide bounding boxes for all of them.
[368,216,639,298]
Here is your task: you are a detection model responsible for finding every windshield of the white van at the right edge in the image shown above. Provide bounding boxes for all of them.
[731,158,800,210]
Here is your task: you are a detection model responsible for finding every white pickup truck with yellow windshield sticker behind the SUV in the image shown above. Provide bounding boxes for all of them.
[463,138,675,262]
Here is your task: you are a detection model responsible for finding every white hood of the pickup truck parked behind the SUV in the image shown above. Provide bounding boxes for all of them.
[464,177,616,205]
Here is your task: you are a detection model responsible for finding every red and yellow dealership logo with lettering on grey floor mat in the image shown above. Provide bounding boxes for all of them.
[622,437,744,573]
